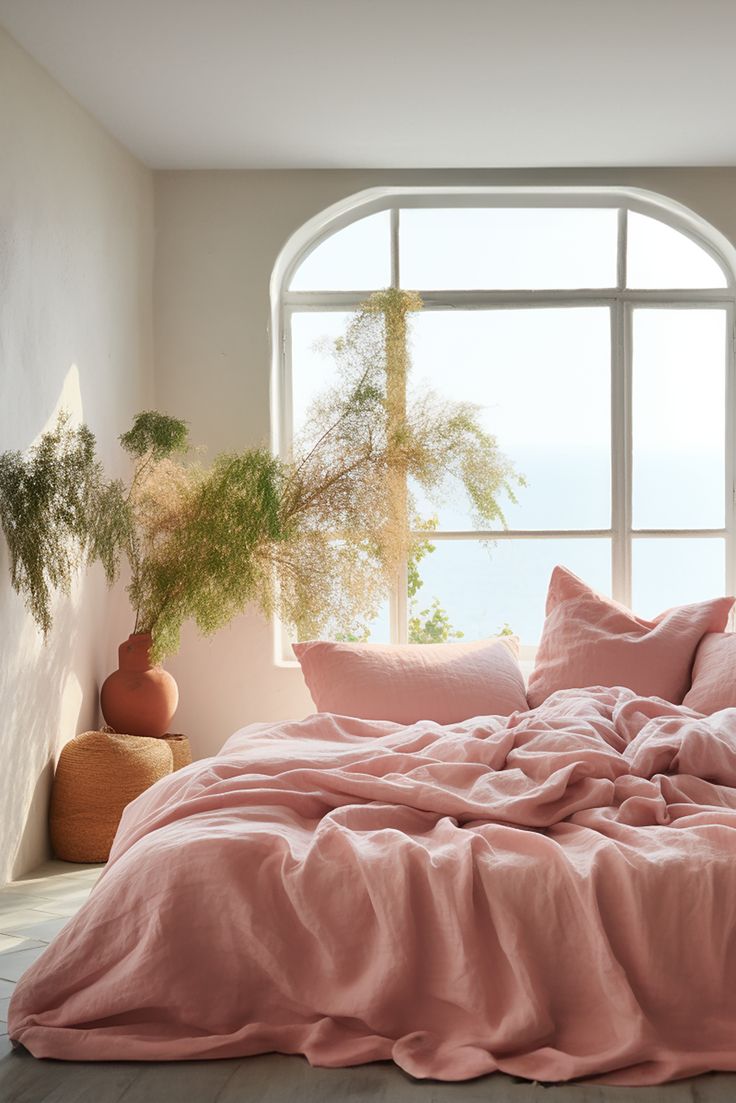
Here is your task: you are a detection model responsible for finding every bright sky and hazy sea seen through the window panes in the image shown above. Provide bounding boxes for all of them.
[291,208,726,646]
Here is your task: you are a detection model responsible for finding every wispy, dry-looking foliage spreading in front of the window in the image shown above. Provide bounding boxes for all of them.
[285,289,523,639]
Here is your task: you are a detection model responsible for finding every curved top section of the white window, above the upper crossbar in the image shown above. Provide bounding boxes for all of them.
[277,189,734,292]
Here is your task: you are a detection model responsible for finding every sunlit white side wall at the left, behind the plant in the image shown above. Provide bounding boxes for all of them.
[0,30,153,884]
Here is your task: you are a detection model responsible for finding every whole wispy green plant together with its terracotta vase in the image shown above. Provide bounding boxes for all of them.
[0,290,523,736]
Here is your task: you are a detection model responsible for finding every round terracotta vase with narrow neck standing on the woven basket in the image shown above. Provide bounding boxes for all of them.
[99,632,179,738]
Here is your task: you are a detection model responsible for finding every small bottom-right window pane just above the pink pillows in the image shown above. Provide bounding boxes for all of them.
[631,536,726,619]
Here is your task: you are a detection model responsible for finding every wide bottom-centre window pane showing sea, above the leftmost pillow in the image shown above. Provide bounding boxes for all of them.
[409,538,611,645]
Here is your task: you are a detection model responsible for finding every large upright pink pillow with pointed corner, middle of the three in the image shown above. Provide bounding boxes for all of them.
[526,567,734,708]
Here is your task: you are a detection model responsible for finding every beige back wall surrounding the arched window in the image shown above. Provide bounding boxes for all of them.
[154,169,736,756]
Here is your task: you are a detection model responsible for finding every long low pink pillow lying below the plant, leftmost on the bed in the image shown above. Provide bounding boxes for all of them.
[294,636,527,724]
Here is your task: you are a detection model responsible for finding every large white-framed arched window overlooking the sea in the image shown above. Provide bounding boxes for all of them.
[275,189,735,654]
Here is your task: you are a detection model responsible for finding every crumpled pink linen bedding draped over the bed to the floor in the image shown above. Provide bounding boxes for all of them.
[9,689,736,1084]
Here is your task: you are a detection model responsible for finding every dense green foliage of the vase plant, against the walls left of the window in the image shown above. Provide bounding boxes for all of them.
[0,410,288,660]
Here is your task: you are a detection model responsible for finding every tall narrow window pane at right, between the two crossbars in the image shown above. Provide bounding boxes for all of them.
[632,309,726,528]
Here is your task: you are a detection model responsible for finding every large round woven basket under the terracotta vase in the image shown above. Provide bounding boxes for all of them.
[50,731,173,861]
